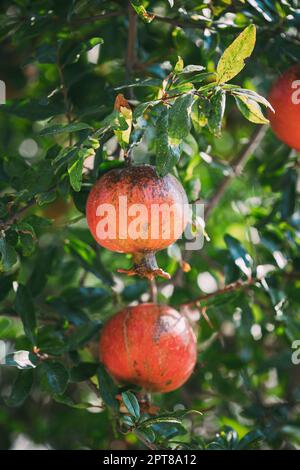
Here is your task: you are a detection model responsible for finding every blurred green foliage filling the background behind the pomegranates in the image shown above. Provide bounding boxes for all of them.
[0,0,300,449]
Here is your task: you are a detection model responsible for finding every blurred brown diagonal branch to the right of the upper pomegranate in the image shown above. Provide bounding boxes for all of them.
[205,126,267,219]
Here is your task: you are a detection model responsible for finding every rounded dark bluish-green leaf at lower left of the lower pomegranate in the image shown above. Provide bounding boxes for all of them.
[38,361,69,395]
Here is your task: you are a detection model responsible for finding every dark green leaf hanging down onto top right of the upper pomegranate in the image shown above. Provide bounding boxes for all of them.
[156,107,180,176]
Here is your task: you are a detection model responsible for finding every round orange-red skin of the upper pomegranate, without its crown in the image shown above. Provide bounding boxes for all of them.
[86,165,188,253]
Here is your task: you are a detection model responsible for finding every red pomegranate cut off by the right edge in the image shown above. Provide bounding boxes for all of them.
[268,65,300,150]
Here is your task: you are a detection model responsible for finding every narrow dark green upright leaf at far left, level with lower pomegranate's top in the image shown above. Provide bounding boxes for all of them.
[15,284,37,346]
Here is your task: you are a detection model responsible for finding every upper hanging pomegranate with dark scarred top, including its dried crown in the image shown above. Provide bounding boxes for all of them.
[86,165,188,279]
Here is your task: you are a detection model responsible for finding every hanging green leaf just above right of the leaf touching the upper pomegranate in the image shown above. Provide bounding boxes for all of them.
[168,94,194,145]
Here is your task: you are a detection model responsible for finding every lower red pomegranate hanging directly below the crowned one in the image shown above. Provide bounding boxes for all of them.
[100,303,197,392]
